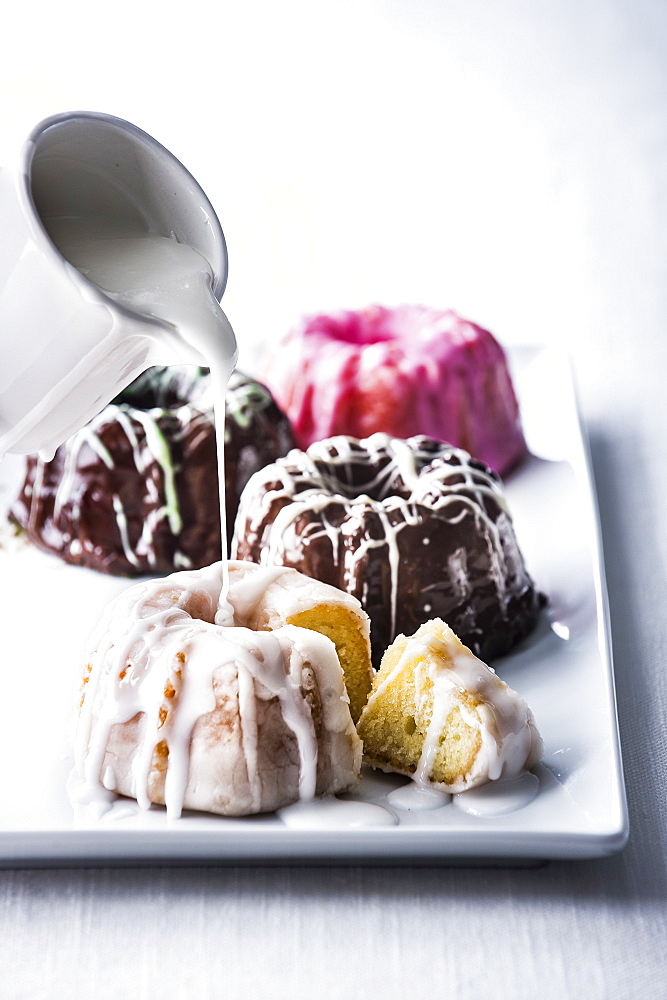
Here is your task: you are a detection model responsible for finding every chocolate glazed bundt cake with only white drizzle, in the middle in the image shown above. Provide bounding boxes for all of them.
[232,434,541,666]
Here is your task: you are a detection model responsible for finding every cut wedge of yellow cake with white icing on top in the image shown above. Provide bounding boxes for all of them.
[357,619,542,792]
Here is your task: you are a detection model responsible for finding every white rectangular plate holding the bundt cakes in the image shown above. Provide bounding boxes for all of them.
[0,347,628,867]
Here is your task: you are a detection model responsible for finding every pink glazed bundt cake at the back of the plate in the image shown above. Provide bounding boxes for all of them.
[264,305,526,475]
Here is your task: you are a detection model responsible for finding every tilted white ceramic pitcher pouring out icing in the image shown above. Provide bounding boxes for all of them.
[0,111,227,458]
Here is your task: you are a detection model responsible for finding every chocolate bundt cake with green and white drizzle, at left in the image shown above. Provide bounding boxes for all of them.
[11,366,294,576]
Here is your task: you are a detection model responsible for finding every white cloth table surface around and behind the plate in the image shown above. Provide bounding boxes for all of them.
[0,0,667,1000]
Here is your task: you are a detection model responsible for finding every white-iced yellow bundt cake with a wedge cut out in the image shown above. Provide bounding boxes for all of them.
[74,563,371,816]
